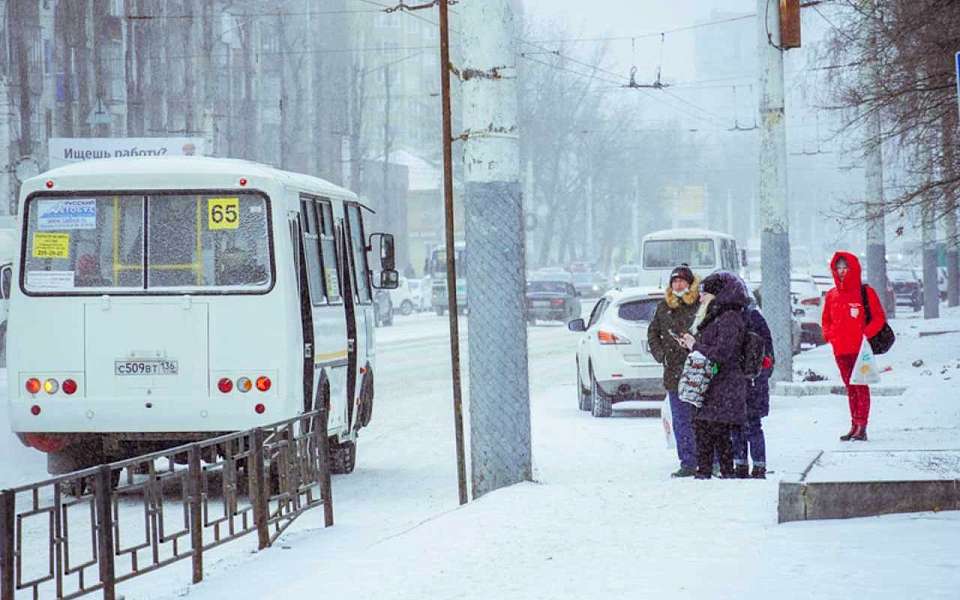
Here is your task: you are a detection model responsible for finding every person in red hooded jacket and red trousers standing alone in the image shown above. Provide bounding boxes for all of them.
[823,252,887,442]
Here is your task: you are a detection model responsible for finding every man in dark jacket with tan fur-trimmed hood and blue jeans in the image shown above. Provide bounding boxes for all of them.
[647,265,700,477]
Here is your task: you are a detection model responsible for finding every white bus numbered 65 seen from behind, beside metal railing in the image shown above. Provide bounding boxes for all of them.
[8,157,397,474]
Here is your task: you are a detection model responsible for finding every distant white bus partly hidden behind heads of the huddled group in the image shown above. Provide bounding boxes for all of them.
[638,229,742,288]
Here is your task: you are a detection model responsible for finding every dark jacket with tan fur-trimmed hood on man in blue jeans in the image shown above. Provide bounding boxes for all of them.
[647,278,700,392]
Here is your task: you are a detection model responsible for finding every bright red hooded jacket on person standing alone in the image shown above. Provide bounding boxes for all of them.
[823,252,887,356]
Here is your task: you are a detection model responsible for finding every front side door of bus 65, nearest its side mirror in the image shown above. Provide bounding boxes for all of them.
[343,204,375,424]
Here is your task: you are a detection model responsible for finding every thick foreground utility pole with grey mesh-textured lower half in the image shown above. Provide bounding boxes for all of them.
[460,0,533,497]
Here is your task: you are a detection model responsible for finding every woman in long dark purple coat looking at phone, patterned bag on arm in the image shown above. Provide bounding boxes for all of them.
[683,271,750,479]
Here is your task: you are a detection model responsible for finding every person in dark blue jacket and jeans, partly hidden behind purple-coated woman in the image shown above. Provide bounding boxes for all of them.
[733,305,774,479]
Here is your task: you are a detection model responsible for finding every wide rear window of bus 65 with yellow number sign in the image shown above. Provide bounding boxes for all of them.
[22,192,273,294]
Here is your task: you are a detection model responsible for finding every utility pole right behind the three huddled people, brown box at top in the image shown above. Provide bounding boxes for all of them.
[757,0,793,381]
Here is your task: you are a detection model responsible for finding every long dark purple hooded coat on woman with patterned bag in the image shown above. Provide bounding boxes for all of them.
[693,271,750,425]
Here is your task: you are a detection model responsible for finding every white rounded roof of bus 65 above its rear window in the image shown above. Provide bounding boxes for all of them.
[23,156,368,209]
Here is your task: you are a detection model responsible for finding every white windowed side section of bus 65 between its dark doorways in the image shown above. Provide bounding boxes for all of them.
[299,195,353,431]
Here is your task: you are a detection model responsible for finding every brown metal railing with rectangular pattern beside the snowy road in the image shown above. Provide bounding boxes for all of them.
[0,410,333,600]
